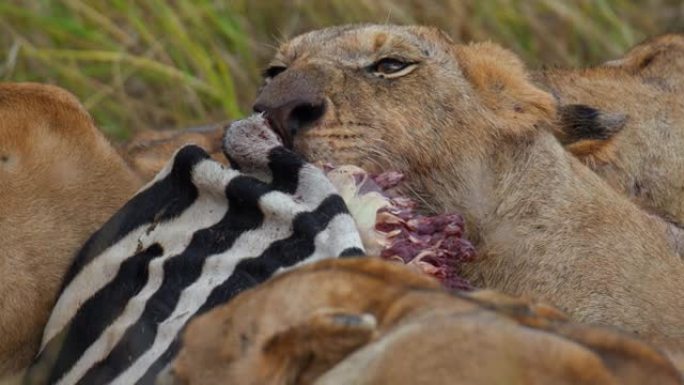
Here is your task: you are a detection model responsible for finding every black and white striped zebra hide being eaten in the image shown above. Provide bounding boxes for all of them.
[25,116,363,385]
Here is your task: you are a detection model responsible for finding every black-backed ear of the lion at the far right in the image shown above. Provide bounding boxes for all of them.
[555,104,627,164]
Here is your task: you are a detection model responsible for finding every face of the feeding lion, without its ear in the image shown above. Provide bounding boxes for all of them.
[255,26,464,172]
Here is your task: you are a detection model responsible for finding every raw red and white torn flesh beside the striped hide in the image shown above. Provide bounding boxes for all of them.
[323,165,475,290]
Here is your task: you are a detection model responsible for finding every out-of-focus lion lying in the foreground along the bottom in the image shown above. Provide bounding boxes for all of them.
[170,258,682,385]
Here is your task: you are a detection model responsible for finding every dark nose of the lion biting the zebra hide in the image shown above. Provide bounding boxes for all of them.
[253,98,325,147]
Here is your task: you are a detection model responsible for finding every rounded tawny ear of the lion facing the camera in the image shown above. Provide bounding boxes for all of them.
[456,42,556,135]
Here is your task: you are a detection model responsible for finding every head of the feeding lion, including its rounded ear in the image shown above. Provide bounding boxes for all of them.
[254,25,555,210]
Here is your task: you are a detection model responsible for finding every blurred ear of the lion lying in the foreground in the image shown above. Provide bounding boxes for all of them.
[263,309,377,383]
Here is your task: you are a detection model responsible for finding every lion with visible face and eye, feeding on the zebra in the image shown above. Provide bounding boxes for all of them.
[254,25,684,350]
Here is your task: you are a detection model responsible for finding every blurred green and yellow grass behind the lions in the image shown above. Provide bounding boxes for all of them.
[0,0,684,139]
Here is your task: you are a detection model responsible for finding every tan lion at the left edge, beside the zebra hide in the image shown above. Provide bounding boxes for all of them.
[0,83,141,378]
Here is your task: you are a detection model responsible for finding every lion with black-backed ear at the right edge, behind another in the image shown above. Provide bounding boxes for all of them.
[534,34,684,231]
